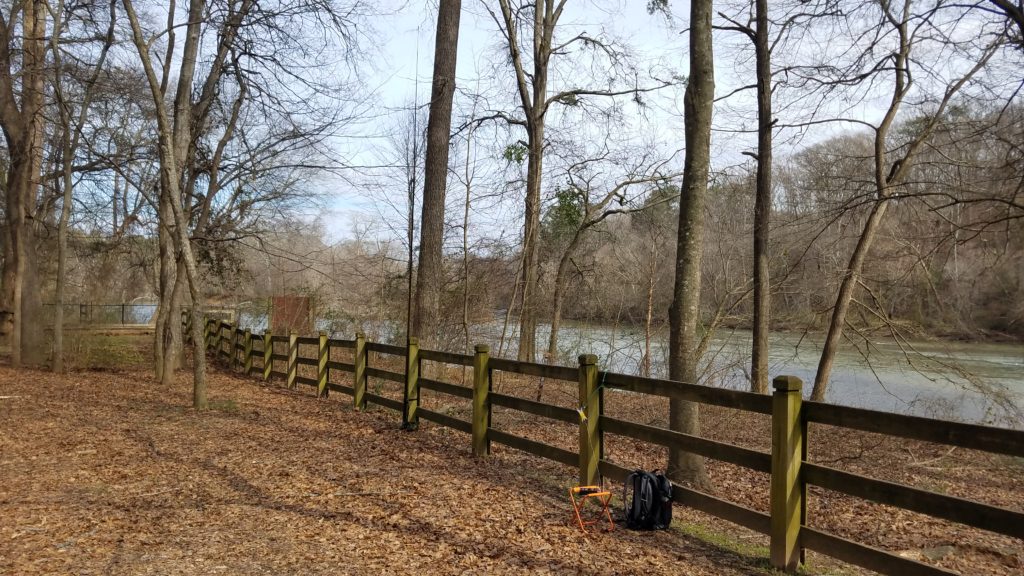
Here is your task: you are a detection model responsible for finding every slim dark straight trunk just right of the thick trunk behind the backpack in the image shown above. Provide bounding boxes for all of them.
[751,0,774,394]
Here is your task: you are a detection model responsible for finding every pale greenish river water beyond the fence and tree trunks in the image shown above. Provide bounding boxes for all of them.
[481,324,1024,428]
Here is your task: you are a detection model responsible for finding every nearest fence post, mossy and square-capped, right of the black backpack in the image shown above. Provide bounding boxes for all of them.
[771,376,806,572]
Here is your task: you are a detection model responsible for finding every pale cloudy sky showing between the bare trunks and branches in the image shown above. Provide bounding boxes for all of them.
[311,0,1013,240]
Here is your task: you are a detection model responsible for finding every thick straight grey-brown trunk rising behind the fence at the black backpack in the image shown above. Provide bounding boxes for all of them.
[669,0,715,487]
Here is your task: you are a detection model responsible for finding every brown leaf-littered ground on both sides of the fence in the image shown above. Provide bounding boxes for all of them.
[0,352,1024,575]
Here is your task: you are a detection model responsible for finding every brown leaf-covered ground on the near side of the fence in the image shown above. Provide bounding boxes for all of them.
[0,367,782,575]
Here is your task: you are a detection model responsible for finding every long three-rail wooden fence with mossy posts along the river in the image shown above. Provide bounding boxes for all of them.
[190,315,1024,576]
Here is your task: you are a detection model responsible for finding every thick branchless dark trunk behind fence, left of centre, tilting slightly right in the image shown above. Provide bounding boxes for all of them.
[413,0,462,346]
